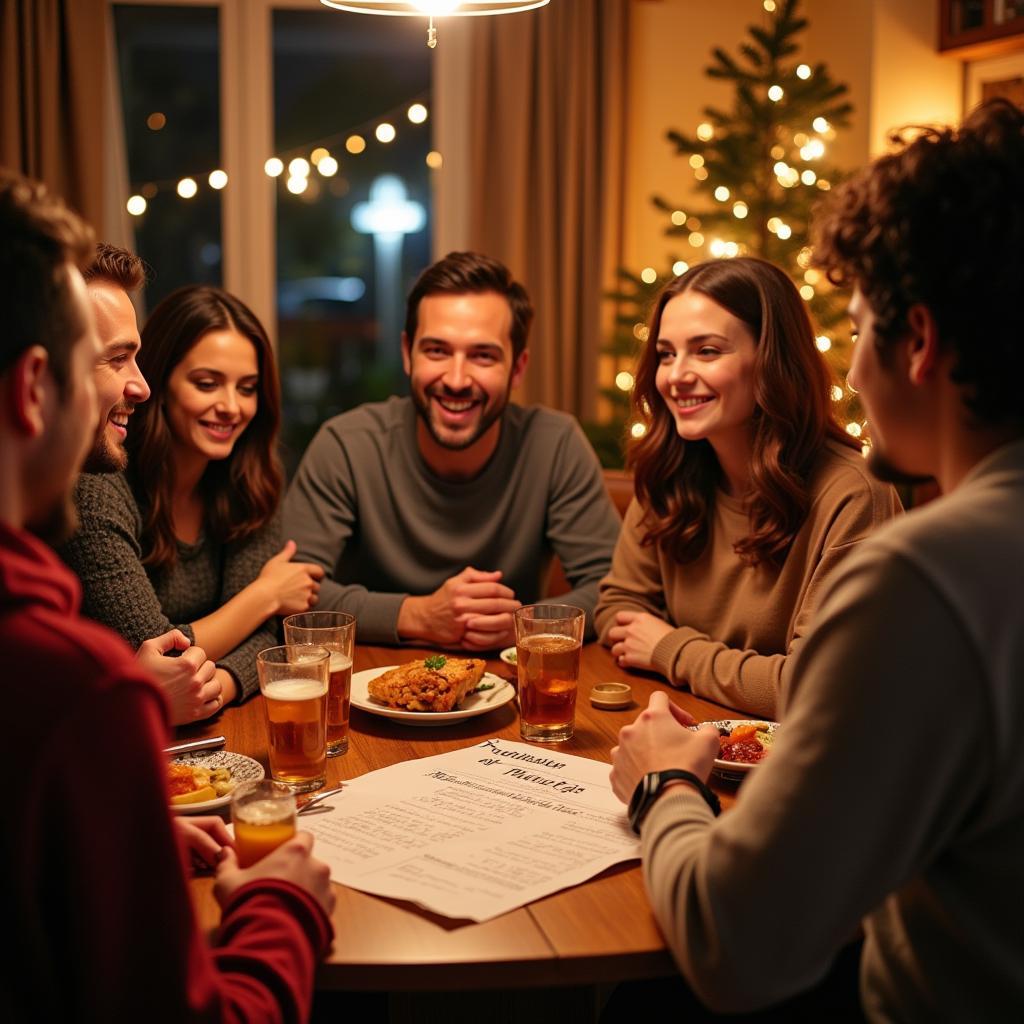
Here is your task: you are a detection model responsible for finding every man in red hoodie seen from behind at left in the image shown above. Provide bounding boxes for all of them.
[0,172,334,1021]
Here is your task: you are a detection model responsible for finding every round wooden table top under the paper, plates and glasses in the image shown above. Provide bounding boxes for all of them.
[179,644,742,992]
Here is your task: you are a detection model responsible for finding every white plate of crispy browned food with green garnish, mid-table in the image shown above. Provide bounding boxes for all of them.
[352,654,515,726]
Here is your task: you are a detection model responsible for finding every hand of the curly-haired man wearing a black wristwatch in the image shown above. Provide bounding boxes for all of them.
[611,690,719,804]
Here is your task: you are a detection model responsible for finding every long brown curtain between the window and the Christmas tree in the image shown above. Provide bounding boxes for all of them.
[439,0,629,420]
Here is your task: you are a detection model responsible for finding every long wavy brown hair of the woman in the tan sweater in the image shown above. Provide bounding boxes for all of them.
[627,257,857,565]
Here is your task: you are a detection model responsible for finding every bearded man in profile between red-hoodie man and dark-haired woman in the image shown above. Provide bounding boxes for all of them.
[60,243,224,725]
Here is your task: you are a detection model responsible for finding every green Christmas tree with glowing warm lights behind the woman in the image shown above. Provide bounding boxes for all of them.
[591,0,862,464]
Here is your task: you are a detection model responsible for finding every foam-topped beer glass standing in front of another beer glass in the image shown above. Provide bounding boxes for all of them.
[256,644,331,793]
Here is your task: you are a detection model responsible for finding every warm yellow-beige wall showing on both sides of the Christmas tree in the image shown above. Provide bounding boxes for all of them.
[624,0,963,269]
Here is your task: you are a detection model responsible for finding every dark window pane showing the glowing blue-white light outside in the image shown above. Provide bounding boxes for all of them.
[273,10,431,466]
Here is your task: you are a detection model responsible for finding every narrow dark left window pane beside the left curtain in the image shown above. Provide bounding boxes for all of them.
[114,4,221,308]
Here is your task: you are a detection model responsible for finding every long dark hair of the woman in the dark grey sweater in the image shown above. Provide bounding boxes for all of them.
[127,285,284,569]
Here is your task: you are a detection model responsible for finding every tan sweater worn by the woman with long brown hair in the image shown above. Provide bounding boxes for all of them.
[595,442,900,718]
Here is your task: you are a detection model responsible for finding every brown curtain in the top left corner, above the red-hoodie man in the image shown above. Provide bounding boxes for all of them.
[0,0,106,230]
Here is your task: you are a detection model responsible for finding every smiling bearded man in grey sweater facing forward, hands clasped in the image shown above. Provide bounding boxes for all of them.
[285,253,620,650]
